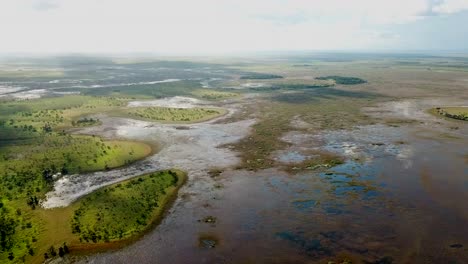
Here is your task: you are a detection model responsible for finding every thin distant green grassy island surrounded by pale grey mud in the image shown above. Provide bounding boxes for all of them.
[118,107,225,122]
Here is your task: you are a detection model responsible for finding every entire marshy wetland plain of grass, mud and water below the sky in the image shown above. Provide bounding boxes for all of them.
[0,54,468,264]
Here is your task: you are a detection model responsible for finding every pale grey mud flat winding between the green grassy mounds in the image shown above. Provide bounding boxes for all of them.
[42,99,255,208]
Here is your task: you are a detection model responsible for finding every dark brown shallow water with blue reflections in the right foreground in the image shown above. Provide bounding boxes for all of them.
[77,99,468,263]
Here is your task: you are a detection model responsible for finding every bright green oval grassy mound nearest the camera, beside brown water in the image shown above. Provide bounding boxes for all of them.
[71,170,185,243]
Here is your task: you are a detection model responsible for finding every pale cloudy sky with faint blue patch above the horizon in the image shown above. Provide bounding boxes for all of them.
[0,0,468,54]
